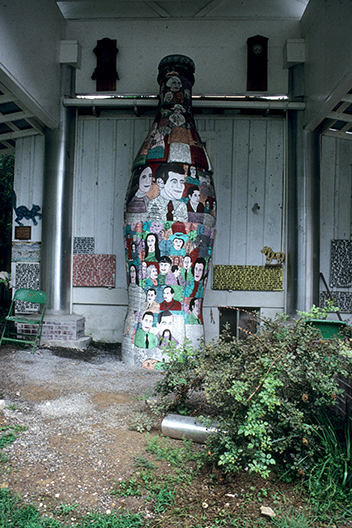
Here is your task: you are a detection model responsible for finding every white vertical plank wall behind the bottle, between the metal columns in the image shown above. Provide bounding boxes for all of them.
[73,116,285,341]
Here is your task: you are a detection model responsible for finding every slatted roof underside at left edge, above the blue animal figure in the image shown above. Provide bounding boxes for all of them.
[0,83,44,155]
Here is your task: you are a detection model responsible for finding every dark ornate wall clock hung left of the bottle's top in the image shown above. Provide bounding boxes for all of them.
[92,37,119,92]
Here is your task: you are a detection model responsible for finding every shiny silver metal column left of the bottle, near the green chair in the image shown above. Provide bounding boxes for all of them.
[41,64,76,315]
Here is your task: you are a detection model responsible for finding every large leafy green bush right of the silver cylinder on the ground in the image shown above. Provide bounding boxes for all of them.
[156,314,352,477]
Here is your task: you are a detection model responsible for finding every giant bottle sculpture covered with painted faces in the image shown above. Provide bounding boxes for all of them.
[122,55,216,364]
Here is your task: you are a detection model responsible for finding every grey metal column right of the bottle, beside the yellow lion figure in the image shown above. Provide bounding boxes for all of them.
[286,111,320,317]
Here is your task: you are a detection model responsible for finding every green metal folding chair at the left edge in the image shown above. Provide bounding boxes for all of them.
[0,288,47,352]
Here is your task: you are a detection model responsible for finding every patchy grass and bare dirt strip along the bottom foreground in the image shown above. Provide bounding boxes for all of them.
[0,426,350,528]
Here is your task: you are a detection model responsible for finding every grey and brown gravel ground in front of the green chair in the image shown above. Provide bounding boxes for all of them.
[0,346,162,513]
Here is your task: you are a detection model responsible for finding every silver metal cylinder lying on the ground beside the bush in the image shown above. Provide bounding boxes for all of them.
[161,414,217,444]
